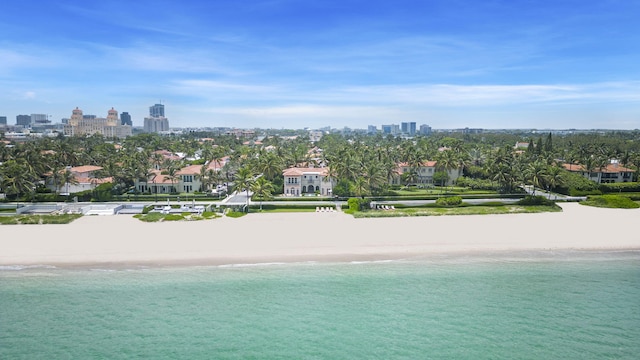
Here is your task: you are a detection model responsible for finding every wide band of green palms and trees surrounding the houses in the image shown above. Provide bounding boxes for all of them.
[0,133,640,201]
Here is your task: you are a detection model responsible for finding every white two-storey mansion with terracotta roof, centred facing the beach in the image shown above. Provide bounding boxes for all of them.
[282,167,334,196]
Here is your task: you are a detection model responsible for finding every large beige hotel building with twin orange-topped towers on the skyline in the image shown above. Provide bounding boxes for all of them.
[64,107,131,138]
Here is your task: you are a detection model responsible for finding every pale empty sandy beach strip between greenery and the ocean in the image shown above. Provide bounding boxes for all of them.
[0,203,640,266]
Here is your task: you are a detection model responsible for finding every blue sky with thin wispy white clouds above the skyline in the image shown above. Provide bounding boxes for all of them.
[0,0,640,129]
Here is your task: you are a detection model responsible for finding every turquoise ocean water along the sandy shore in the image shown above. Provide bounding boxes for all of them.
[0,251,640,359]
